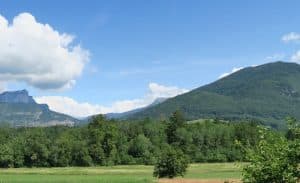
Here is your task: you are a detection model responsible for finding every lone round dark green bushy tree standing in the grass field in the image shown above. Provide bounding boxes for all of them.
[153,146,188,178]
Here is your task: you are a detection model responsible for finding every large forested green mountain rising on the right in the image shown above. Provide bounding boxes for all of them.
[127,62,300,127]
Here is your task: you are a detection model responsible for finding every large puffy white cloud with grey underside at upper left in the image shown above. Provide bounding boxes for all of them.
[0,13,89,89]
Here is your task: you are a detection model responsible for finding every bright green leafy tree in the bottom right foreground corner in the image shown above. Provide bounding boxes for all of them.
[243,120,300,183]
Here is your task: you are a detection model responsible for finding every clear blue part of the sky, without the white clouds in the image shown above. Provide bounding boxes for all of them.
[0,0,300,116]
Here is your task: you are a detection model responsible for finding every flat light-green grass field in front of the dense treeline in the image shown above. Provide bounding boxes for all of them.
[0,163,241,183]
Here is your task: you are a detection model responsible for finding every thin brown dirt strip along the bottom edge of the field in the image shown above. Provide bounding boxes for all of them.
[159,178,241,183]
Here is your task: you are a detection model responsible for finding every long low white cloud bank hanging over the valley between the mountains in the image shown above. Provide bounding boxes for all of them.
[35,83,188,117]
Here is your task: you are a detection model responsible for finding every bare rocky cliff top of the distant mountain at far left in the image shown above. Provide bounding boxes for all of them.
[0,90,35,104]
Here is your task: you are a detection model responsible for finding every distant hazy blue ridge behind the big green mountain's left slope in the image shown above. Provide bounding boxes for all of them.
[105,97,167,119]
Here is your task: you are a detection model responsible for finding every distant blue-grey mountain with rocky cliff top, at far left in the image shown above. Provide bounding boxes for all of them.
[0,90,80,126]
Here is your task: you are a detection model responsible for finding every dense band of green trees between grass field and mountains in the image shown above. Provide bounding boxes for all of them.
[0,111,258,167]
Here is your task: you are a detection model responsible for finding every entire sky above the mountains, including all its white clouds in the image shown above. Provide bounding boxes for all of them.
[0,0,300,117]
